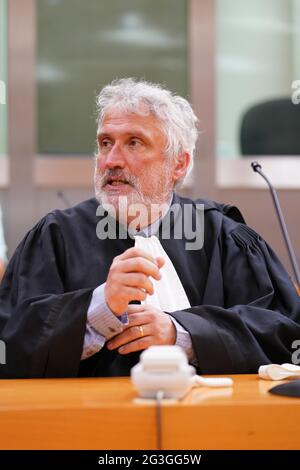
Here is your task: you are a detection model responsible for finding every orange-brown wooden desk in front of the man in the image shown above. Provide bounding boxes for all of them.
[0,375,300,450]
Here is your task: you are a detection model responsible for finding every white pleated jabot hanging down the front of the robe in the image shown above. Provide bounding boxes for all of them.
[134,235,191,312]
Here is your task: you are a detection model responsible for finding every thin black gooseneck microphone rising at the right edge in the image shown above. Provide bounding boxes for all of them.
[251,162,300,296]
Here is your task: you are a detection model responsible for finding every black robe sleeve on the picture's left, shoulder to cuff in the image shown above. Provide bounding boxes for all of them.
[0,214,93,378]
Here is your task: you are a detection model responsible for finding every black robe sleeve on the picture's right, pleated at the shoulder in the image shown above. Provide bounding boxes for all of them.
[172,224,300,374]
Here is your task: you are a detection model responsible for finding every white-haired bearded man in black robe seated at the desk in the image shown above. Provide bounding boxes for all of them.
[0,79,300,377]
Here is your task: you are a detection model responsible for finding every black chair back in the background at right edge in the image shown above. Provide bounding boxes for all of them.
[240,98,300,155]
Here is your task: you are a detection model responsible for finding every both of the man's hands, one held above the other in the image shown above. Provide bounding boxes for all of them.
[105,248,176,354]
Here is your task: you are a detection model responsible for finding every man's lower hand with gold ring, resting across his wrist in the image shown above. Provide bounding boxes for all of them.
[107,305,176,354]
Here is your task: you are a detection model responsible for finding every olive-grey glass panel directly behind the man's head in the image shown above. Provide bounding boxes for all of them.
[36,0,188,156]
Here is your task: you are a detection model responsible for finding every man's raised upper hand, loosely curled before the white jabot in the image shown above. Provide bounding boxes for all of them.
[104,248,164,315]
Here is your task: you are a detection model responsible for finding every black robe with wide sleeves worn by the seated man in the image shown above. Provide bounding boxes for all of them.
[0,195,300,378]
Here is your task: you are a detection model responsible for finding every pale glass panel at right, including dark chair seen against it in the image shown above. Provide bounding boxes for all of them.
[216,0,300,159]
